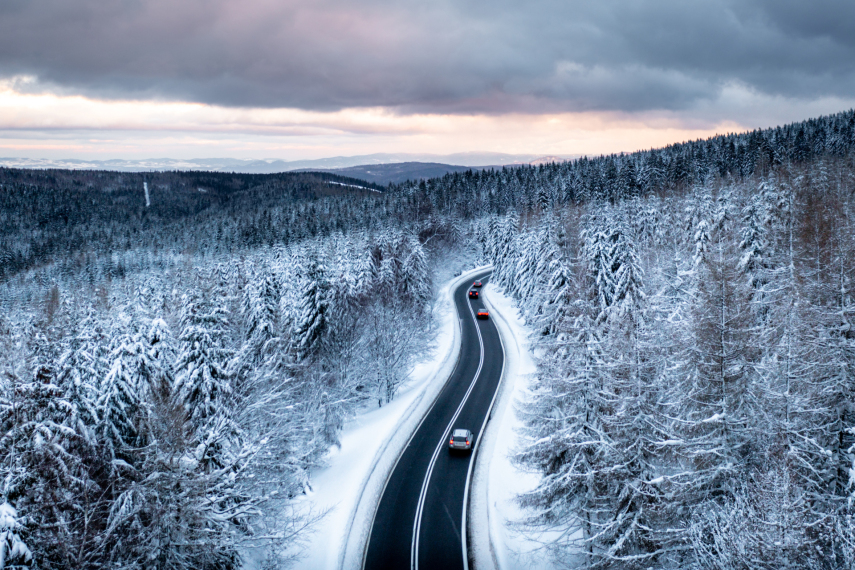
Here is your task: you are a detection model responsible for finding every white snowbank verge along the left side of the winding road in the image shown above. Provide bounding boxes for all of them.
[296,267,486,570]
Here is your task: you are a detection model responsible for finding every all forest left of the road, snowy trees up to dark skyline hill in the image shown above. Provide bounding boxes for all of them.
[0,171,444,569]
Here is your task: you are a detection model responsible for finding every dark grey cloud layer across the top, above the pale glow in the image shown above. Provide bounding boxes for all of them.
[0,0,855,113]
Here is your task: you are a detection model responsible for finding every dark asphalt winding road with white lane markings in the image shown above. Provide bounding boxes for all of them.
[364,272,504,570]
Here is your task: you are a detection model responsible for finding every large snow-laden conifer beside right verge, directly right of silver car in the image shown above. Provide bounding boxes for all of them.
[515,301,620,565]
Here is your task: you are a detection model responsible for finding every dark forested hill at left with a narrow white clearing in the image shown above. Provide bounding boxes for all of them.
[0,168,384,282]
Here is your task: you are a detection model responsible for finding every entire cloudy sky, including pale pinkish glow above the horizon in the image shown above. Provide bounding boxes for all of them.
[0,0,855,160]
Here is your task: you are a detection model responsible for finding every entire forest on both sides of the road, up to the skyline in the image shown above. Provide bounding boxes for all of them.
[0,111,855,569]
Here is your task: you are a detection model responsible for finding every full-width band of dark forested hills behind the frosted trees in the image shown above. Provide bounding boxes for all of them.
[0,110,855,281]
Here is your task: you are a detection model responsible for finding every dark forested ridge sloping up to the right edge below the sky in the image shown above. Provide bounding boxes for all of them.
[390,110,855,210]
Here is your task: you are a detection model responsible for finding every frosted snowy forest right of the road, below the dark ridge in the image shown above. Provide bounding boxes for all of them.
[478,159,855,570]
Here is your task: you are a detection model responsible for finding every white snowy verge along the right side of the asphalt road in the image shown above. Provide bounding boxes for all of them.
[469,283,554,570]
